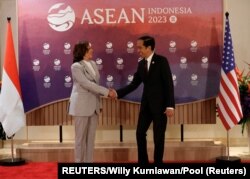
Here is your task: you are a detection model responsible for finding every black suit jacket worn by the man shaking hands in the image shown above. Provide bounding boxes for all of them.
[117,54,175,114]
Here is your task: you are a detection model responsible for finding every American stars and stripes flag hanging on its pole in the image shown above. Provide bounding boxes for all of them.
[218,13,243,130]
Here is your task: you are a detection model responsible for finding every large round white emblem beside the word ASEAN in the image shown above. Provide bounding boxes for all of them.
[47,3,75,32]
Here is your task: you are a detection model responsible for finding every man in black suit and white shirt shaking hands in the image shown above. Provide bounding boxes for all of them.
[113,36,175,164]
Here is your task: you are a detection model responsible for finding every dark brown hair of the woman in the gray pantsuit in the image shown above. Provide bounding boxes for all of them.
[73,41,89,63]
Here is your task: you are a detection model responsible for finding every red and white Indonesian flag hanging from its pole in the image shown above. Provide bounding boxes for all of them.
[0,18,26,137]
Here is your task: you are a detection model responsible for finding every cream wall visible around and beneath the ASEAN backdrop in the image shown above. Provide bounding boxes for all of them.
[0,0,250,145]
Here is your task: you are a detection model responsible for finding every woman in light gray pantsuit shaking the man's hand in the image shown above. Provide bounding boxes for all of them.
[69,41,112,163]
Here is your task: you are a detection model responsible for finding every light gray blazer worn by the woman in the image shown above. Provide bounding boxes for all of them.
[69,61,109,116]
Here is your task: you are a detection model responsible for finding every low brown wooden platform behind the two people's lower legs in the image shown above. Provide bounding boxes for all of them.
[16,141,226,162]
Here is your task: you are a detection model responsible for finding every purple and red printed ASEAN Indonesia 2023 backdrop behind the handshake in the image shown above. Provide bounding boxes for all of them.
[18,0,223,112]
